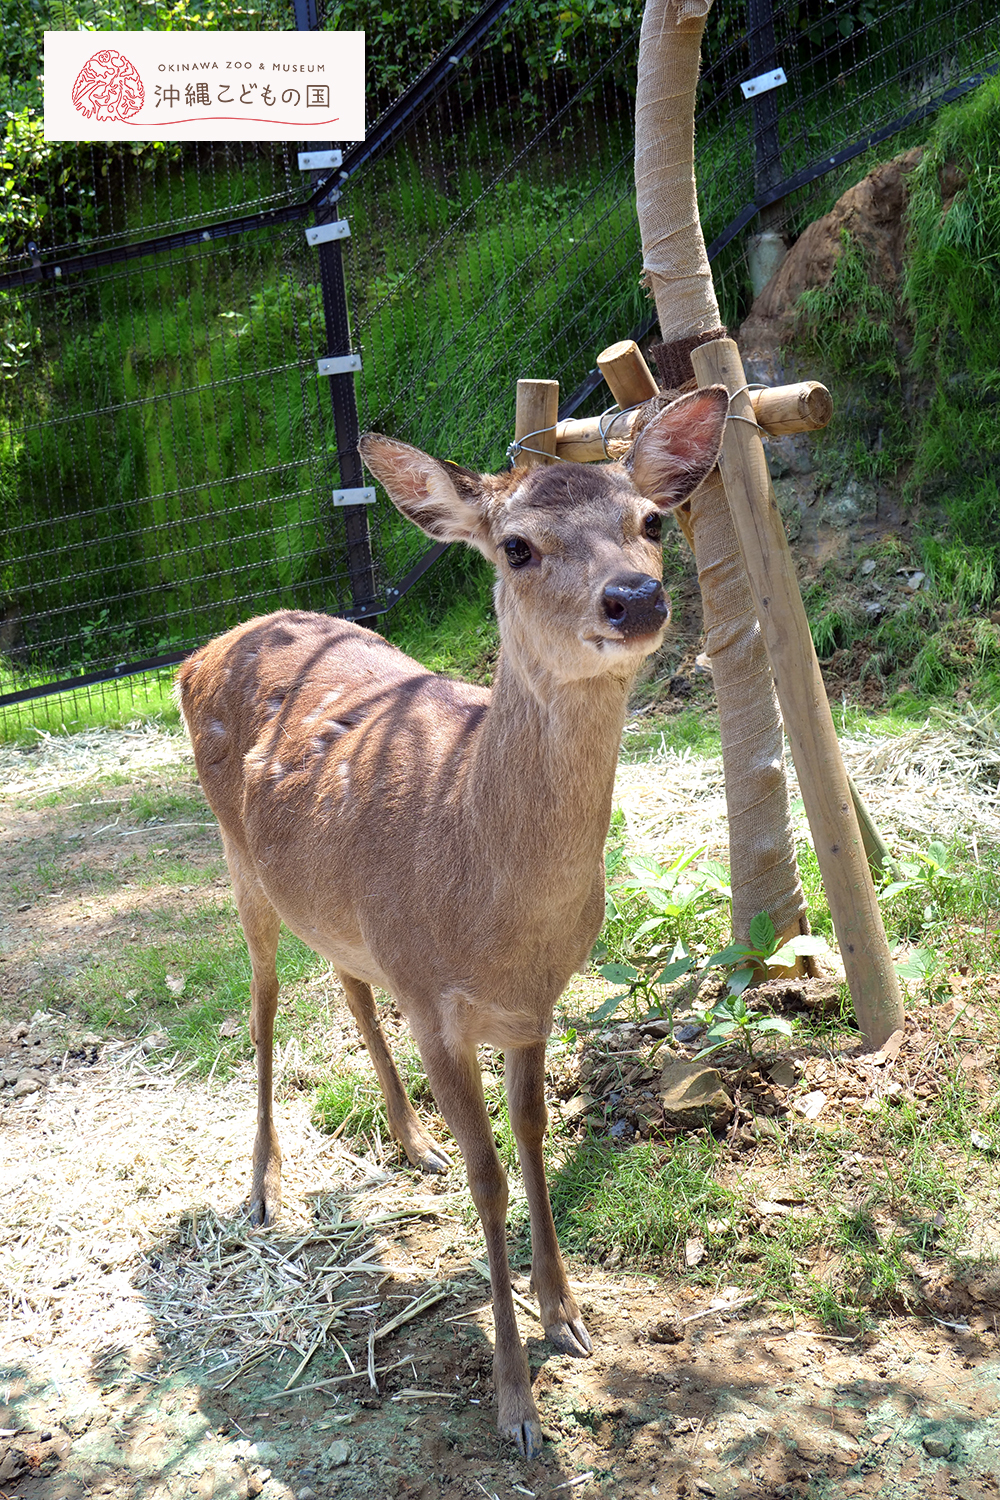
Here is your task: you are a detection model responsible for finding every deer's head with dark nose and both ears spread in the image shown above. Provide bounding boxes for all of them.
[360,386,729,681]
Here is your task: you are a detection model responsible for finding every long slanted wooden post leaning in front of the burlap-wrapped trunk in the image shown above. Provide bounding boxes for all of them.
[691,339,904,1050]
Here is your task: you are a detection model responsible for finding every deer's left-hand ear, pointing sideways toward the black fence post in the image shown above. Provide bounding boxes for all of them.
[358,432,495,561]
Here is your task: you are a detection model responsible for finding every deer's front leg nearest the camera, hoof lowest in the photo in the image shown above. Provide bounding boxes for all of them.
[418,1037,541,1458]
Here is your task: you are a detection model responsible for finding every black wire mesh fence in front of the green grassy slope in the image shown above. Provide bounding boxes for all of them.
[0,0,1000,726]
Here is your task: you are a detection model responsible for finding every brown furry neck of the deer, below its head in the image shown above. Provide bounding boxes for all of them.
[466,654,633,888]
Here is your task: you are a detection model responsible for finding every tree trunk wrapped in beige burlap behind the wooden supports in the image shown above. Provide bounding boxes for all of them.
[636,0,807,941]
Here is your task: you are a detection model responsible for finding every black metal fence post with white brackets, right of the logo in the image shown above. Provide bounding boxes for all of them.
[294,0,378,626]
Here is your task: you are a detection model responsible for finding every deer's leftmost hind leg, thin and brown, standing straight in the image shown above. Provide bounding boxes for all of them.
[222,833,282,1224]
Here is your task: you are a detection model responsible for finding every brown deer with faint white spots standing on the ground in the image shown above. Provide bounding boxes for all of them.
[178,386,729,1458]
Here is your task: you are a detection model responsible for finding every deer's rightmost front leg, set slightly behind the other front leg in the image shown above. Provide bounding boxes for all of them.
[504,1043,594,1355]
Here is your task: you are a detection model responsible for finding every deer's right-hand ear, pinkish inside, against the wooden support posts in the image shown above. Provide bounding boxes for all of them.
[625,386,729,510]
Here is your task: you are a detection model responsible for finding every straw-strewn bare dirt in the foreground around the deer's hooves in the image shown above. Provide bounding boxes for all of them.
[0,1038,1000,1500]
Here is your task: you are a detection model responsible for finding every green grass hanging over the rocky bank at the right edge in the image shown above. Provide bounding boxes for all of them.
[795,78,1000,699]
